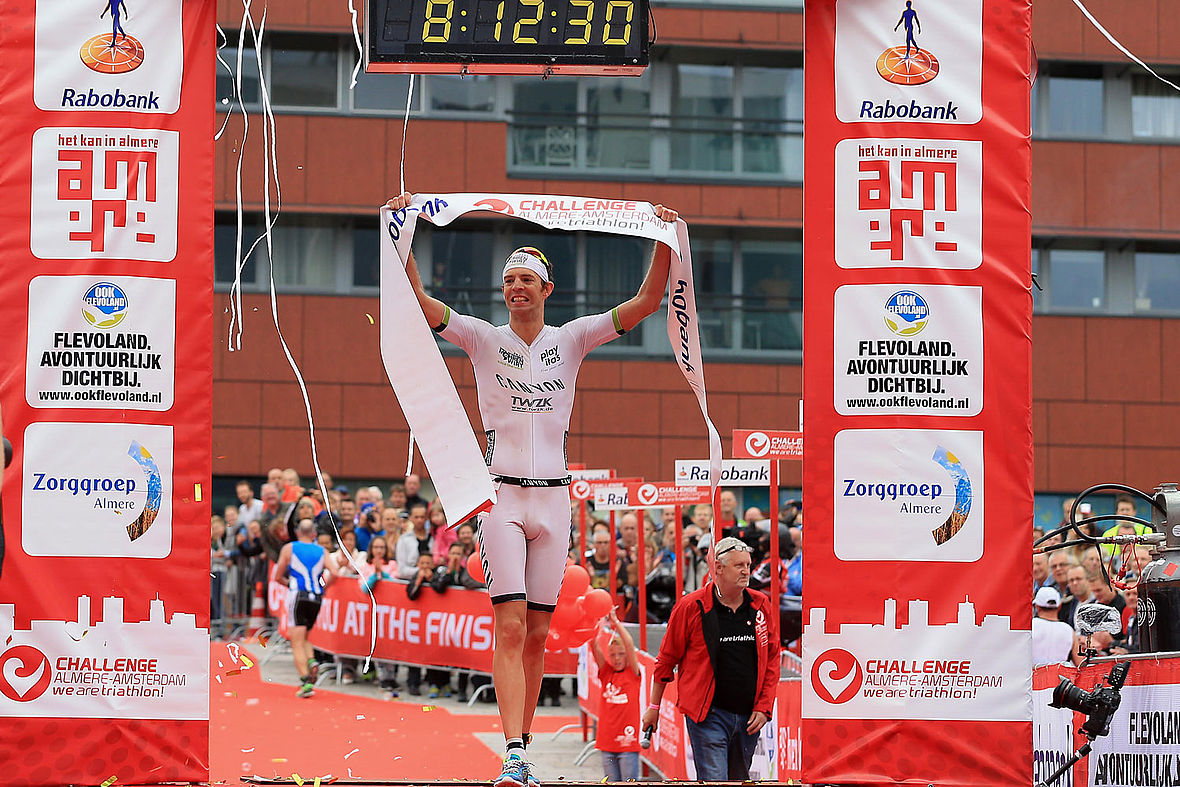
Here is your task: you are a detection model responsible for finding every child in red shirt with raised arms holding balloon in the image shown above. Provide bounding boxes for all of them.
[590,610,640,781]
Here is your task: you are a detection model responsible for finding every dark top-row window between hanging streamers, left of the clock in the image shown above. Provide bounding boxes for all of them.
[269,34,339,110]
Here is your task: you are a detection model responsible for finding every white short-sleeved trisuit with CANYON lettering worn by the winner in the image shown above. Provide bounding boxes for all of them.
[434,308,623,611]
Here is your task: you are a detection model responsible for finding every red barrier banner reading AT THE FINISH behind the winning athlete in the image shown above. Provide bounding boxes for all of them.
[304,578,577,675]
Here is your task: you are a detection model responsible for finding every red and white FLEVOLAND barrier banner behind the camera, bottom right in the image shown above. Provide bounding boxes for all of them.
[1033,656,1180,787]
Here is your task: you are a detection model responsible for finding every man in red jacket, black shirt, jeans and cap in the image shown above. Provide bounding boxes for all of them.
[642,538,780,781]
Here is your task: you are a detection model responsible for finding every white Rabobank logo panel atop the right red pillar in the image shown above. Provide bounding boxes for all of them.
[834,0,983,124]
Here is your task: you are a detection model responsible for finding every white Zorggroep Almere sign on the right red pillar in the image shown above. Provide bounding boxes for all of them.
[833,429,984,562]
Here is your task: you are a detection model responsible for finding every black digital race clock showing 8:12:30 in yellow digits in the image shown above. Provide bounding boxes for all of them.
[366,0,648,74]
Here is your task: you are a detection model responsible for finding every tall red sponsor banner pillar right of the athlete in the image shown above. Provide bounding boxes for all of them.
[802,0,1033,787]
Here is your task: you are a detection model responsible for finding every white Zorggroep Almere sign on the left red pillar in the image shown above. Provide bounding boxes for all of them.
[21,422,172,557]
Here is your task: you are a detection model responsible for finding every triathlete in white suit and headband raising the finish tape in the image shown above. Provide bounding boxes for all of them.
[388,187,677,787]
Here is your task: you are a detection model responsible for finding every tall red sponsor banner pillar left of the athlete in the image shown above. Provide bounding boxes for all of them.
[0,0,215,786]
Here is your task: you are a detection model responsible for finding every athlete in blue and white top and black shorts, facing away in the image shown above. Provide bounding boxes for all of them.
[275,519,333,697]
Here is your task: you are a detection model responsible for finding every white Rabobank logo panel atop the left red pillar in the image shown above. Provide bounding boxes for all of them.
[33,0,184,113]
